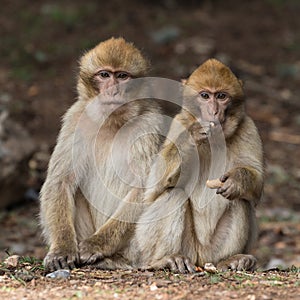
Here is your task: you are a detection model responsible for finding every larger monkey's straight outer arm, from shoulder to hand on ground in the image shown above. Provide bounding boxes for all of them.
[40,105,84,271]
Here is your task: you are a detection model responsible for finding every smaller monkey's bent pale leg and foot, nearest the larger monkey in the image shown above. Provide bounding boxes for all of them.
[135,188,195,273]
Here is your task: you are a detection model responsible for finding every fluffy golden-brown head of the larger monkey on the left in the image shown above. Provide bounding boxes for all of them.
[77,38,149,104]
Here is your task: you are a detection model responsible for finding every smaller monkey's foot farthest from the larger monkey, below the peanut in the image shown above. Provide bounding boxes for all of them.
[217,254,257,271]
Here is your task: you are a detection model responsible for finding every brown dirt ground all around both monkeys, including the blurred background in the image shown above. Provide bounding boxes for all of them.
[0,0,300,300]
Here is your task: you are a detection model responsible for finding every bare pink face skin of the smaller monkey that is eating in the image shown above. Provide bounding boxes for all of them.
[198,90,231,125]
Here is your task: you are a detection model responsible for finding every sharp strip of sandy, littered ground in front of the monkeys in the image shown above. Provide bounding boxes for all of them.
[0,263,300,300]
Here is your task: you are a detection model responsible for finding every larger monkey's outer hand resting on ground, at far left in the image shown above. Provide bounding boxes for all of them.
[44,250,78,272]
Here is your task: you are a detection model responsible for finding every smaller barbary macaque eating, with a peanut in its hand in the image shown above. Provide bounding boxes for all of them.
[134,59,263,272]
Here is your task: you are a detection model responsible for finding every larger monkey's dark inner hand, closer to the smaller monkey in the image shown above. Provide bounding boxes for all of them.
[79,237,104,265]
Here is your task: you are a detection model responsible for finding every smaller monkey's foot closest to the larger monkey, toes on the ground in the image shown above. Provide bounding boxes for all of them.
[145,255,196,273]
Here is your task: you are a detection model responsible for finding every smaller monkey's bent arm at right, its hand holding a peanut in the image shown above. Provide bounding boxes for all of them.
[217,117,264,205]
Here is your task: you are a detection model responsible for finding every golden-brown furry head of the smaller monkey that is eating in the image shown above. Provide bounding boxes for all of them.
[186,59,244,137]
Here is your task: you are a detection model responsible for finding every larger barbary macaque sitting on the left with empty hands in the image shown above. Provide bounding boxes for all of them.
[40,38,172,271]
